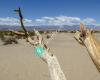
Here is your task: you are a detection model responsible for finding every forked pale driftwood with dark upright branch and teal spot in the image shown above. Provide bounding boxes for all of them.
[12,8,66,80]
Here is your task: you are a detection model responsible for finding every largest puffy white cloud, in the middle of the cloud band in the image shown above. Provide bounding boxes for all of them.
[35,16,80,25]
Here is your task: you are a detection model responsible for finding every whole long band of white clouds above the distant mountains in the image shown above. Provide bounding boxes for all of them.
[0,16,96,26]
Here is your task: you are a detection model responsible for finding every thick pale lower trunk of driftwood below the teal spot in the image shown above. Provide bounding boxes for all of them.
[42,52,66,80]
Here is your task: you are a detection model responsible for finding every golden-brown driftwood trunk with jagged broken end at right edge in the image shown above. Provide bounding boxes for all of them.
[74,23,100,72]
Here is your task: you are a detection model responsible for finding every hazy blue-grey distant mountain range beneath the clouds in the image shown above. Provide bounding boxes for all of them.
[0,25,100,30]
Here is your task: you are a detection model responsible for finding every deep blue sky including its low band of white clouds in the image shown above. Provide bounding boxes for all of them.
[0,0,100,25]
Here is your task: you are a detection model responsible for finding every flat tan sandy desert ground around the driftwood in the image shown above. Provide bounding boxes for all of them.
[0,33,100,80]
